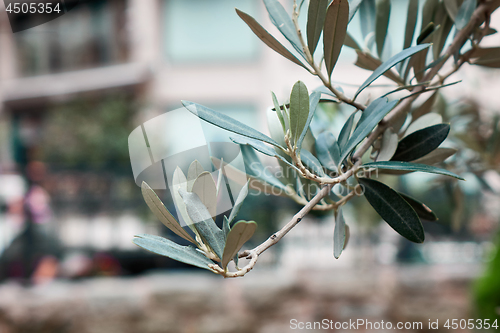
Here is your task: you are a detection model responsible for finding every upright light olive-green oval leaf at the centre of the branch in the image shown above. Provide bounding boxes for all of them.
[290,81,309,146]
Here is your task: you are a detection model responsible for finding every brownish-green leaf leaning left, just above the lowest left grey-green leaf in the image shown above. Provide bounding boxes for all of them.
[141,182,196,244]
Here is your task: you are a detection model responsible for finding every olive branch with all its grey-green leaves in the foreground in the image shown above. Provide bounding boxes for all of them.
[136,0,500,277]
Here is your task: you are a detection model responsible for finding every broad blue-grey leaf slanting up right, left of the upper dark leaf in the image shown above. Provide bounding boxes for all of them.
[340,98,399,162]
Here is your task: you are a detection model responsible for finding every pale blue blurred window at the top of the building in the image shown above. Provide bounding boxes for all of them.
[163,0,259,62]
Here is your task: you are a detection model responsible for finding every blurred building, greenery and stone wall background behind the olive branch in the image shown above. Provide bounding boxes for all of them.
[0,0,500,333]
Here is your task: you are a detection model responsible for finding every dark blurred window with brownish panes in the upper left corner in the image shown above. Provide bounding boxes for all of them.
[15,0,125,76]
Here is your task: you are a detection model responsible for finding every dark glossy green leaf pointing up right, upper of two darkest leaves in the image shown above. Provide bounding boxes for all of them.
[392,124,450,161]
